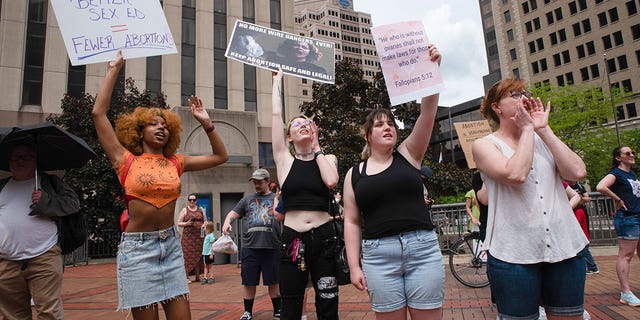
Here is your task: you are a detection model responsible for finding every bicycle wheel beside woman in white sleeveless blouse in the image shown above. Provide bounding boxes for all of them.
[449,232,489,288]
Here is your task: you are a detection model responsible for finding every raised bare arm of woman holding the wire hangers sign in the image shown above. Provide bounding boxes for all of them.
[271,69,293,183]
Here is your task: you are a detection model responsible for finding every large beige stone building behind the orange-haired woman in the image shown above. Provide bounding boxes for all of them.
[0,0,298,235]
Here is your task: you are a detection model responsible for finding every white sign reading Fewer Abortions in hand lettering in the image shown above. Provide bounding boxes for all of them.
[51,0,178,66]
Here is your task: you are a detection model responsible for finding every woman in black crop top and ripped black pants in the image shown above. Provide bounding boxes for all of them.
[271,70,339,320]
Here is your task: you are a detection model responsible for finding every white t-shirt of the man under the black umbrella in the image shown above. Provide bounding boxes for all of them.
[0,179,58,260]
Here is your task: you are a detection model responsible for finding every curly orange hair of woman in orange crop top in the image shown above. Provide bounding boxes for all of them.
[115,107,182,157]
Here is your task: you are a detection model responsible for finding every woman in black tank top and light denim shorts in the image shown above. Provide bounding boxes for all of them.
[342,45,445,320]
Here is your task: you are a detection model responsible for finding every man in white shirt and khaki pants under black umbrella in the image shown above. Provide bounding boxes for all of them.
[0,142,80,319]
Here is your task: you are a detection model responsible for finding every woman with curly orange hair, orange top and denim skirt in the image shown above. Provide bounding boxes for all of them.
[92,52,228,319]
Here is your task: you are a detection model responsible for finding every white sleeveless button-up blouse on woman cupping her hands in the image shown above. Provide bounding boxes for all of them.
[482,134,588,264]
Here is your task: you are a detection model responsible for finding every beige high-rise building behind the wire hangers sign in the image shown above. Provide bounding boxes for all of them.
[294,0,380,102]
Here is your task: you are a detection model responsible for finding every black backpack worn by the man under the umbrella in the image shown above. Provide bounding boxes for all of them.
[0,175,88,255]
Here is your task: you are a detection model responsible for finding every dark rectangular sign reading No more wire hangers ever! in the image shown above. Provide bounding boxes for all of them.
[225,20,335,83]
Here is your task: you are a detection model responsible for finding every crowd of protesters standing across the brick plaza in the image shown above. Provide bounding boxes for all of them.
[0,41,640,320]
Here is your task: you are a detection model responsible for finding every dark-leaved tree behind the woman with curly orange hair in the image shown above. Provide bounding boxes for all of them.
[47,78,167,252]
